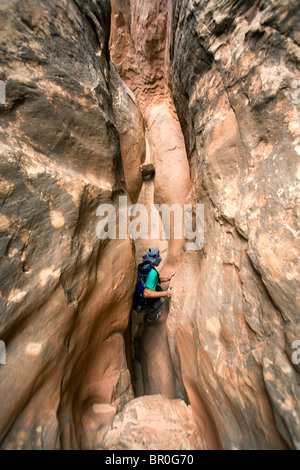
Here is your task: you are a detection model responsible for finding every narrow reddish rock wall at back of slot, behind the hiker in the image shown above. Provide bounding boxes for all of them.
[111,0,190,408]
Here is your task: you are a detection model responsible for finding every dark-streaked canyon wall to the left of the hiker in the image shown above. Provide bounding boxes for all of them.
[0,1,139,449]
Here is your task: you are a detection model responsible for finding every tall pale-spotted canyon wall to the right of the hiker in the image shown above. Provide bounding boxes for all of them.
[169,1,300,448]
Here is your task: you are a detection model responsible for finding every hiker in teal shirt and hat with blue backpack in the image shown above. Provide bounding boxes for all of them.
[136,248,175,323]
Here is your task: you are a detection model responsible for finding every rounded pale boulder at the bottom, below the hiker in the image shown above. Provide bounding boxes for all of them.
[103,395,206,450]
